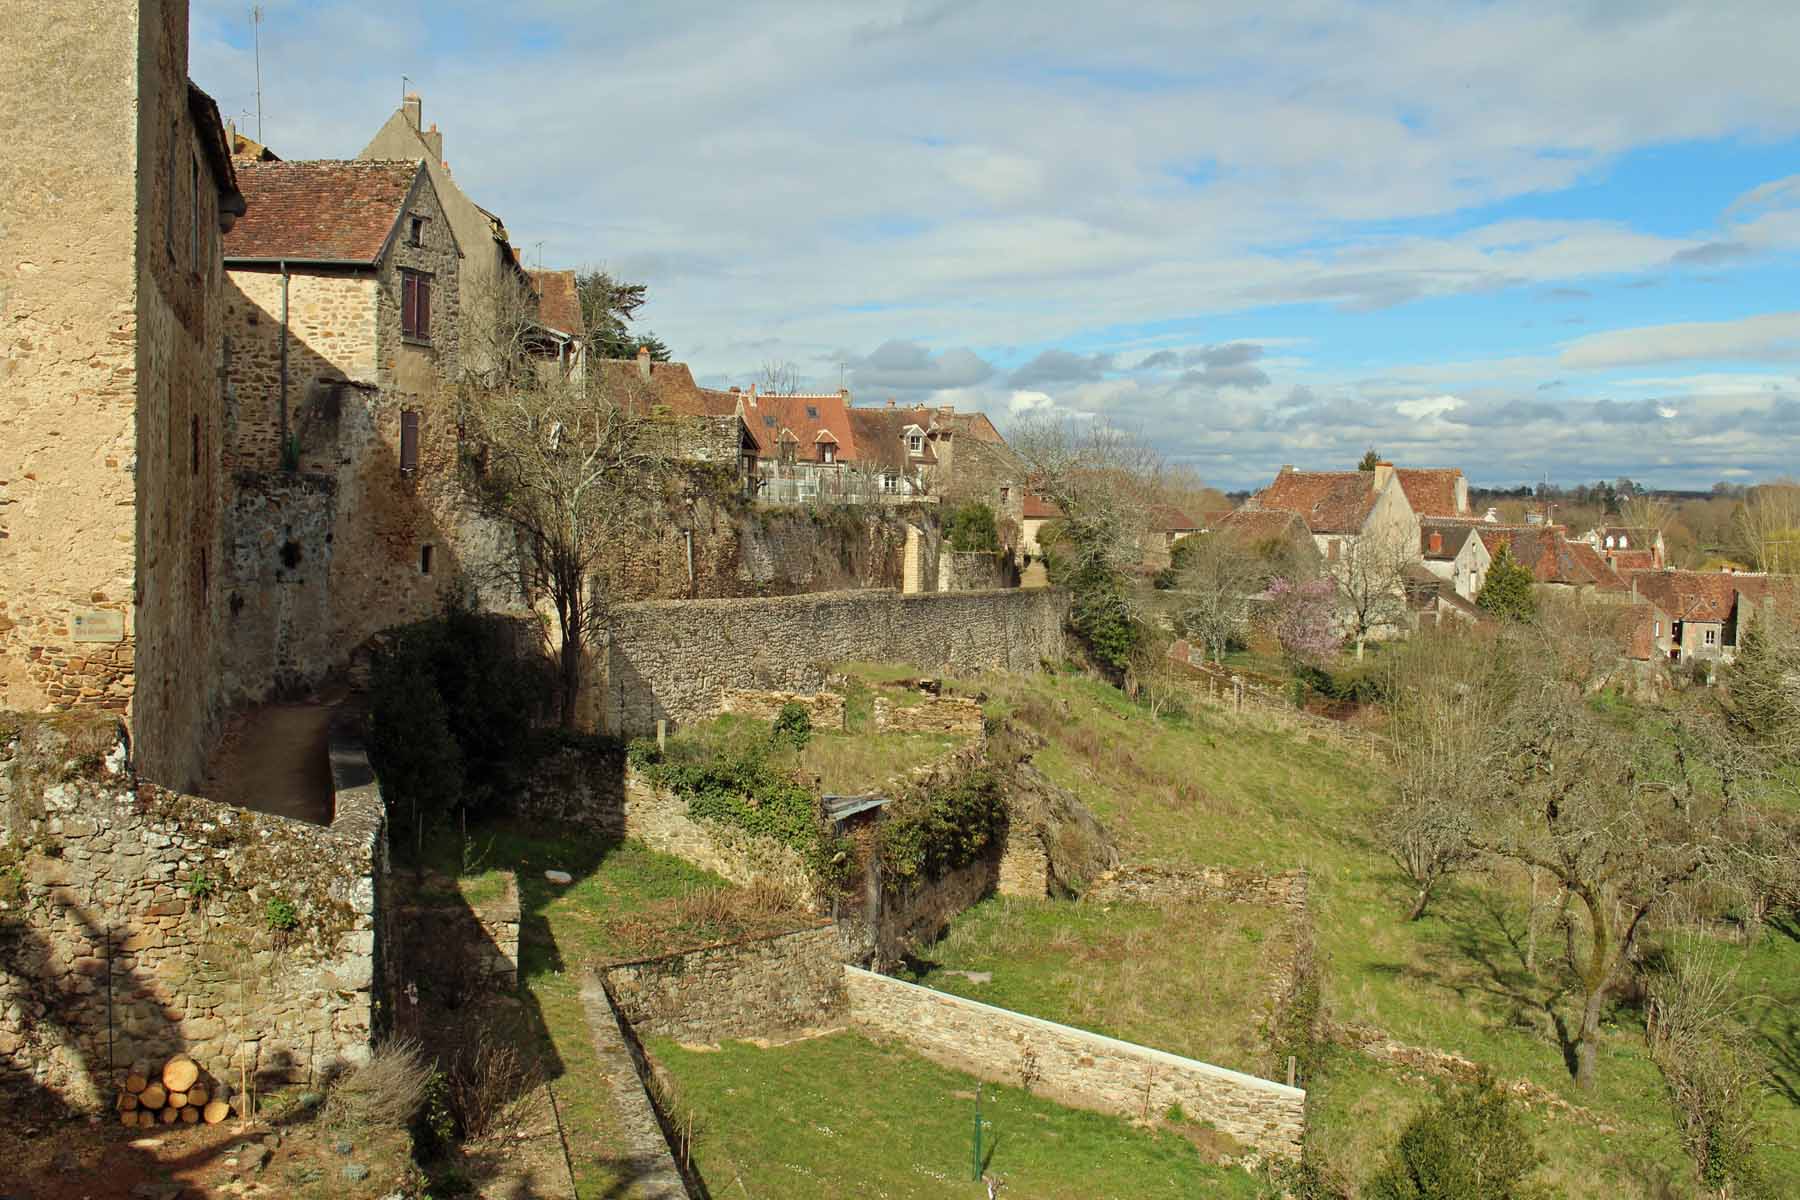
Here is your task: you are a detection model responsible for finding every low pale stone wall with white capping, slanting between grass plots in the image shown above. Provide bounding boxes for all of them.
[844,966,1307,1159]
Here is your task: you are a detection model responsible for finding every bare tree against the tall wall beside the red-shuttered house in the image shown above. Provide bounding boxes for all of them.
[459,275,666,727]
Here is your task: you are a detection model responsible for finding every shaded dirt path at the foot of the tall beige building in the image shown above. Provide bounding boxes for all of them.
[205,696,338,824]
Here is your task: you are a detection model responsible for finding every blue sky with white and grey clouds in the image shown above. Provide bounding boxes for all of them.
[189,0,1800,489]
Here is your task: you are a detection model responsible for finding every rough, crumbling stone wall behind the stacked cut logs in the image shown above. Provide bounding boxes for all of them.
[0,718,387,1105]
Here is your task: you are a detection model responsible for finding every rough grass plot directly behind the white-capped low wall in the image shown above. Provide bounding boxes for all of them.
[911,898,1294,1078]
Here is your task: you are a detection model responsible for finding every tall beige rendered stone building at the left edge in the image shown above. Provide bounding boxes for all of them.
[0,0,245,786]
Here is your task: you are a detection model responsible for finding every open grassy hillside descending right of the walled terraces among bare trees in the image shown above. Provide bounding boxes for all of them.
[992,676,1800,1200]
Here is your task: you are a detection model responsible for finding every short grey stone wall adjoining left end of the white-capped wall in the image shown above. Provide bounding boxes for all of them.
[601,921,851,1042]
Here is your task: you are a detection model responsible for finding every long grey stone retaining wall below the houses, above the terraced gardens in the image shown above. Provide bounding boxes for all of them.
[594,588,1067,736]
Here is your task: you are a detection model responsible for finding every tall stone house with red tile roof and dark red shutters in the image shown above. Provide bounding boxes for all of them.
[221,160,484,703]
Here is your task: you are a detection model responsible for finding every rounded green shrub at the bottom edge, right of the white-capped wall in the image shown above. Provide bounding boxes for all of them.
[1368,1072,1546,1200]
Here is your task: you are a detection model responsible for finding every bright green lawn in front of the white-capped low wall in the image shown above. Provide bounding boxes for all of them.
[650,1033,1256,1200]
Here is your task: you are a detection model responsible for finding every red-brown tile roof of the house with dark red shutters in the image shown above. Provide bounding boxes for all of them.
[223,158,430,266]
